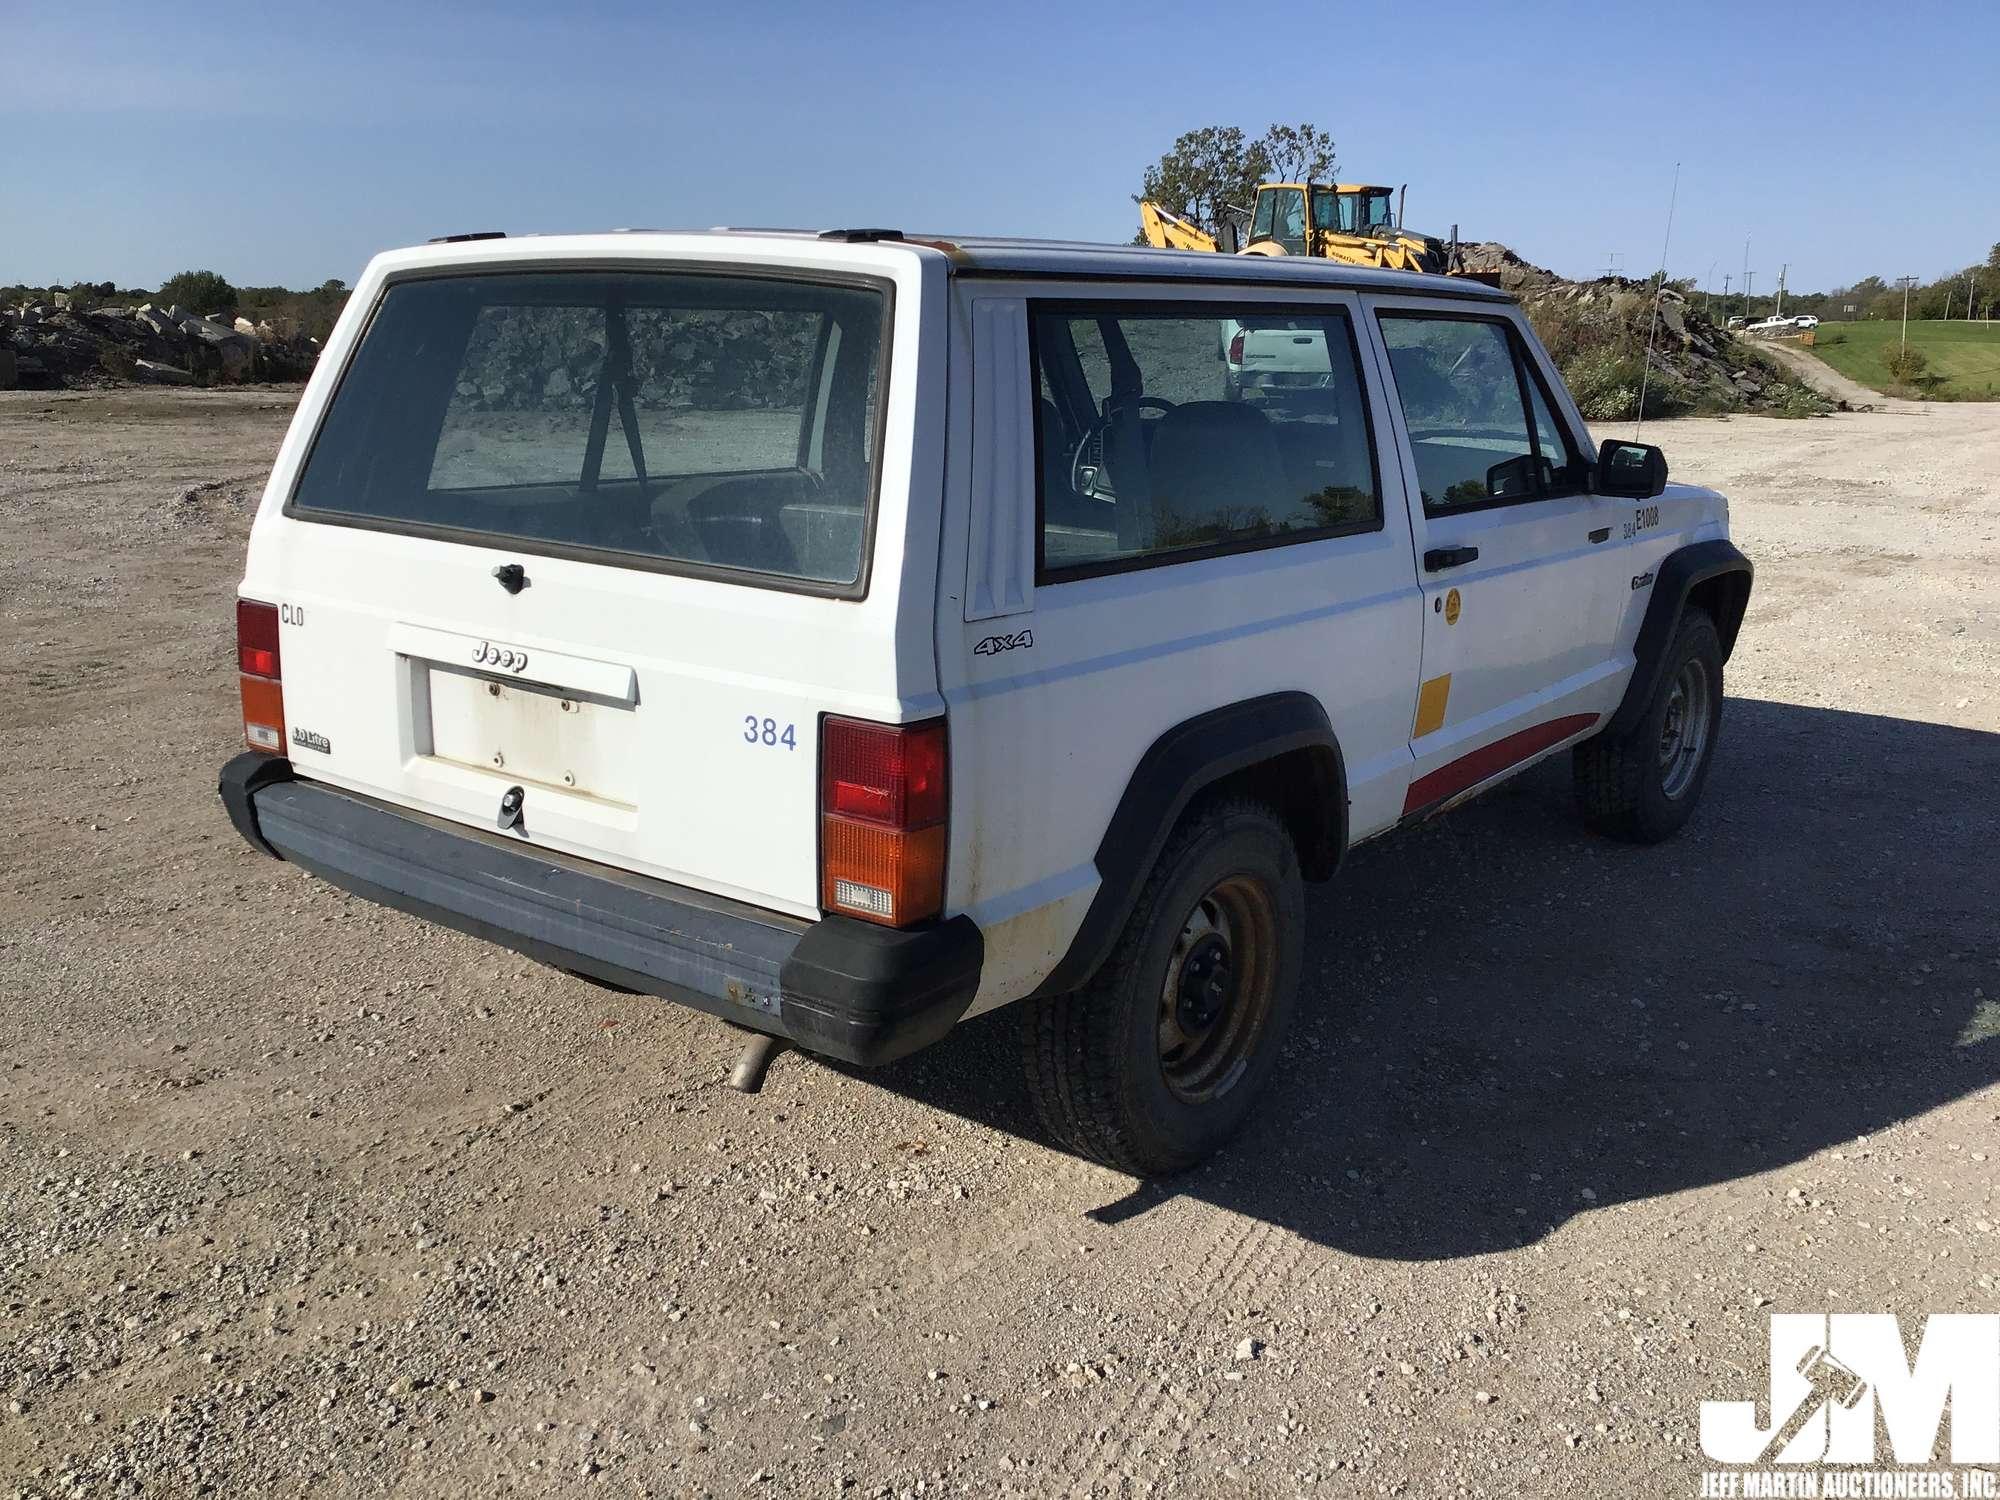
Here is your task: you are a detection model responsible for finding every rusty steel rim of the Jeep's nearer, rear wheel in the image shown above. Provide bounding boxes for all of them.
[1156,876,1278,1104]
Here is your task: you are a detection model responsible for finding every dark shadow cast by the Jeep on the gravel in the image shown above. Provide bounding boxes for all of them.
[848,698,2000,1260]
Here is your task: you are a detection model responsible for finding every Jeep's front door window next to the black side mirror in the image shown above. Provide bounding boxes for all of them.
[1382,312,1578,512]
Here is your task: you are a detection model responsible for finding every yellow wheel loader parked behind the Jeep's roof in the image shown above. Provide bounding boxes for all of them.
[1138,182,1484,280]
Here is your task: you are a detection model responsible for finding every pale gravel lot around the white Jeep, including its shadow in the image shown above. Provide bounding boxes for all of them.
[0,392,2000,1496]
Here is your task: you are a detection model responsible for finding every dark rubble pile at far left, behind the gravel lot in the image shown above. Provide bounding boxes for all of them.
[0,292,320,388]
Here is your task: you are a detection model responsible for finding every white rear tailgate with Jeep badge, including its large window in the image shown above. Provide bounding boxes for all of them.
[242,236,942,916]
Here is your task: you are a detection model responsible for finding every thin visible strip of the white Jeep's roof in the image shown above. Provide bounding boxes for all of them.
[382,228,1512,302]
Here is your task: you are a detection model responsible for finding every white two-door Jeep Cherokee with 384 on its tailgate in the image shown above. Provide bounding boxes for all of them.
[220,230,1750,1172]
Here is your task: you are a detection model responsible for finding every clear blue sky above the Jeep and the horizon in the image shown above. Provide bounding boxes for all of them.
[0,0,2000,290]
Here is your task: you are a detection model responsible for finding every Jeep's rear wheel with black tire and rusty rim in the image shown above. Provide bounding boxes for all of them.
[1024,800,1306,1176]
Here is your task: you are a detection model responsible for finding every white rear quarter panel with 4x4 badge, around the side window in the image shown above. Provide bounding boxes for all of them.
[938,282,1422,1012]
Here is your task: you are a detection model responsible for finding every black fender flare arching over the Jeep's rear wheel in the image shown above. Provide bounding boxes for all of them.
[1034,692,1348,996]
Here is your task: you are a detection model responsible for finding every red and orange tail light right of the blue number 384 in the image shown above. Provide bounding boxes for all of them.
[820,718,946,928]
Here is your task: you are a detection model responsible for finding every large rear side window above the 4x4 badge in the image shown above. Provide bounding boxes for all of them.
[1030,302,1382,582]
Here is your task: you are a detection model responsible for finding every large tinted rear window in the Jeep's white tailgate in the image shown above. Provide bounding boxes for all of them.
[292,272,886,586]
